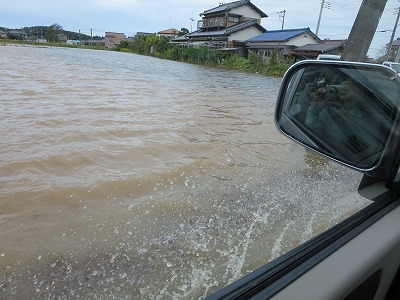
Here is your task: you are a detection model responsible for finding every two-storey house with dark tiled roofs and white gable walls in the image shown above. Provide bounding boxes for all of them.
[173,0,268,54]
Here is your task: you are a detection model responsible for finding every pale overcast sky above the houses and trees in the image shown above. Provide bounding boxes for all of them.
[0,0,400,57]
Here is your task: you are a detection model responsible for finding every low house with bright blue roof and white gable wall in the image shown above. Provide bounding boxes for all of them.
[246,28,322,59]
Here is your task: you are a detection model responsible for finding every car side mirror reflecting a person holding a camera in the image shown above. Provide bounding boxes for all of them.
[275,61,400,177]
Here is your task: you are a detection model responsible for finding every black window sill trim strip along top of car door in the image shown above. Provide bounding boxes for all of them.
[206,192,400,300]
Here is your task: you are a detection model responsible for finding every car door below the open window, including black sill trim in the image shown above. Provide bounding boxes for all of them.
[207,192,400,300]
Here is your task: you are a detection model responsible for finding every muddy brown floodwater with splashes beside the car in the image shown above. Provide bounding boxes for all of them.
[0,46,368,299]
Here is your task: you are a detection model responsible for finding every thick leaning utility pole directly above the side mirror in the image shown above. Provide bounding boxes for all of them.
[342,0,388,62]
